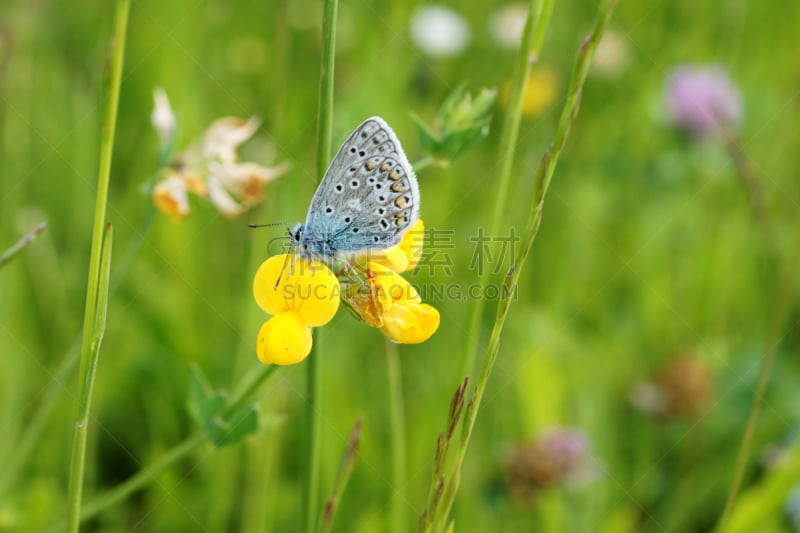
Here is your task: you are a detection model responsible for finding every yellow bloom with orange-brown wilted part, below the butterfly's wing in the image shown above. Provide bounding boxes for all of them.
[342,263,439,344]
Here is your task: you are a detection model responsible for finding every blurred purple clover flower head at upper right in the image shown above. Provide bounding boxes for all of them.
[666,65,742,137]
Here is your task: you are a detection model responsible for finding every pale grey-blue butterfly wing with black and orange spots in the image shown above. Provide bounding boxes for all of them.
[304,117,419,254]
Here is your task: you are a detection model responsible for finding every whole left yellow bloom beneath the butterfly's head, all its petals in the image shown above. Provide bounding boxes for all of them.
[253,254,339,365]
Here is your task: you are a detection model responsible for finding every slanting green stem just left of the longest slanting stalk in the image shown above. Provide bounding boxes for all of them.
[459,0,554,377]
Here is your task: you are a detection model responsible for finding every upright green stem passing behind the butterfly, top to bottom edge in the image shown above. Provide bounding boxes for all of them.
[303,0,339,533]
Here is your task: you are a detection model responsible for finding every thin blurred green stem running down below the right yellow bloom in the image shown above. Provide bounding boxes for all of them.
[386,339,406,533]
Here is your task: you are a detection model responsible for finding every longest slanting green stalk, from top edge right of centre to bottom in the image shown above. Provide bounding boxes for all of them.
[436,0,616,531]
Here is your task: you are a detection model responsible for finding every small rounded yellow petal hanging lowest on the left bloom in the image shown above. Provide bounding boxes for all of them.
[256,311,311,365]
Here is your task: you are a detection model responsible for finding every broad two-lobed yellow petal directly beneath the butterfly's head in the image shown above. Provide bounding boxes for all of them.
[253,254,340,327]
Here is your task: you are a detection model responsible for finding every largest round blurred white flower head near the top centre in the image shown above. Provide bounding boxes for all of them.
[411,4,471,58]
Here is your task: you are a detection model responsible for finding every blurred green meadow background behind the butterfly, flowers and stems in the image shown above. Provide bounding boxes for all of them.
[0,0,800,532]
